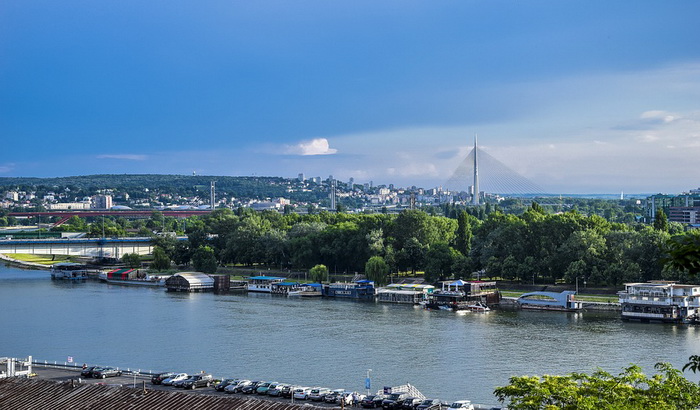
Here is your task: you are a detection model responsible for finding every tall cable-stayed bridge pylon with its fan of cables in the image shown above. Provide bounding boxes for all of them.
[445,143,545,196]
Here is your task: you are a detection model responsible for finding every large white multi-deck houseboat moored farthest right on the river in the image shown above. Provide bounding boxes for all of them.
[618,281,700,323]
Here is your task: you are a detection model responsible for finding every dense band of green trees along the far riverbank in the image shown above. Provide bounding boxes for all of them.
[135,202,699,286]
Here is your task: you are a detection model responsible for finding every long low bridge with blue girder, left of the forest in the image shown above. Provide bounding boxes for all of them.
[0,237,178,258]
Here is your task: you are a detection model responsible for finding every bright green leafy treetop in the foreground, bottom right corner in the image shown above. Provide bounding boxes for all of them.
[494,363,700,410]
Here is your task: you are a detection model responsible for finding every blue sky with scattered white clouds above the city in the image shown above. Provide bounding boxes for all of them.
[0,0,700,193]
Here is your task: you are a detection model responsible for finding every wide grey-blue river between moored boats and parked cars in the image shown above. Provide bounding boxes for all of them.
[0,266,700,404]
